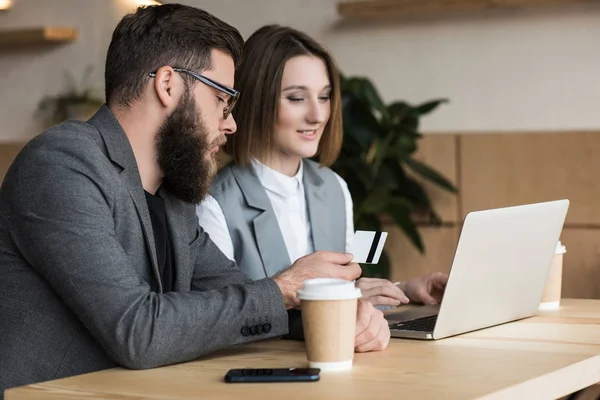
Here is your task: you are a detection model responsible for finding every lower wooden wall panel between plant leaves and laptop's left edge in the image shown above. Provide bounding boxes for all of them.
[385,226,460,282]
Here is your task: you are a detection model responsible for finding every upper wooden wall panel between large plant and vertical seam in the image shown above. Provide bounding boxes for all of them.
[413,135,460,222]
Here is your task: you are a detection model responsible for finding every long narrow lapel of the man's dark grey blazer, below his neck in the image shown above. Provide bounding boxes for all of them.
[88,105,163,293]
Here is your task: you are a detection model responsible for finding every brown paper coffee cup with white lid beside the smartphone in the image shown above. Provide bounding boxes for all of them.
[297,278,361,371]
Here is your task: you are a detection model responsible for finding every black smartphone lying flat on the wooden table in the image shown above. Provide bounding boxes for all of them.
[225,368,321,383]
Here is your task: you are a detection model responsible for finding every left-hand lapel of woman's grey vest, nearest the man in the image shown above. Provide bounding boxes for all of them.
[231,165,291,277]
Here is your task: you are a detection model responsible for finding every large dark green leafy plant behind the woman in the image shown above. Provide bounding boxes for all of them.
[332,76,456,277]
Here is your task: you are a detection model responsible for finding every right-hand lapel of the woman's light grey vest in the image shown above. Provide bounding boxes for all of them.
[302,162,332,251]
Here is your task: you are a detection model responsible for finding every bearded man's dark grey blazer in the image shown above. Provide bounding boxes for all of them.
[0,106,288,397]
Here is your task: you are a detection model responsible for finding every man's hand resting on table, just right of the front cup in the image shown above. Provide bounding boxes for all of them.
[354,299,390,353]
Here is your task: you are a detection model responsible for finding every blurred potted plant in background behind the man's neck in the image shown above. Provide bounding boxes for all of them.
[37,66,104,126]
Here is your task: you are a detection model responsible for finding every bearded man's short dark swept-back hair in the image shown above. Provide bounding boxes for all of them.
[104,4,244,108]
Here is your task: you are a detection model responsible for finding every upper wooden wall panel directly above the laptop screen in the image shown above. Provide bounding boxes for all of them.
[459,132,600,225]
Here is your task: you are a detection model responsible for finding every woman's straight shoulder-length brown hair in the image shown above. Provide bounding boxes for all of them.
[225,25,342,166]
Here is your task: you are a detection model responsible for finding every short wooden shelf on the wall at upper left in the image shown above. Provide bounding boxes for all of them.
[0,26,79,49]
